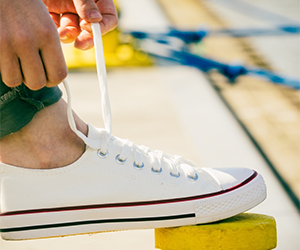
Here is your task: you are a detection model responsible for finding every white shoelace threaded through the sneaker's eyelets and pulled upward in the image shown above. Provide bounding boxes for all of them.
[63,23,198,180]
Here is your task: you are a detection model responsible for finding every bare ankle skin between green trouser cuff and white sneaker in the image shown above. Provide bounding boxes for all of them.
[0,99,88,169]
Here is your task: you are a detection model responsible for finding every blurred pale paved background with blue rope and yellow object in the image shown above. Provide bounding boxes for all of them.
[0,0,300,250]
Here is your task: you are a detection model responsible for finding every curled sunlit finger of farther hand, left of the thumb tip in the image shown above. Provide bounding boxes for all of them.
[58,13,81,43]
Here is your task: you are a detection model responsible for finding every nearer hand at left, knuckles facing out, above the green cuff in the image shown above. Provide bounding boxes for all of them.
[0,0,67,90]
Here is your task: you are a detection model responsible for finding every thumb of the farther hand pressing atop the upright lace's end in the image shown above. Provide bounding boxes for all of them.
[73,0,102,23]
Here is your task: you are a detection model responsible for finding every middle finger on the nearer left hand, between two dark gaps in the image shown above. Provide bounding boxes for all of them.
[20,50,46,90]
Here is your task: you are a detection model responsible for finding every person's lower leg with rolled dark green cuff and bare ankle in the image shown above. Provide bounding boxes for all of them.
[0,76,87,168]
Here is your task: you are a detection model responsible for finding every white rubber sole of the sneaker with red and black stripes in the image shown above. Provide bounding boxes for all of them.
[0,172,266,240]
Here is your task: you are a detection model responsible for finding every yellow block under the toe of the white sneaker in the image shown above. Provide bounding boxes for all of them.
[155,213,277,250]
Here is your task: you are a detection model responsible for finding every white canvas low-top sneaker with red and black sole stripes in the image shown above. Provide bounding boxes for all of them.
[0,25,266,240]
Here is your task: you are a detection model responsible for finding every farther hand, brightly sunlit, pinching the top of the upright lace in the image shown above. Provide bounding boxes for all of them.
[43,0,118,50]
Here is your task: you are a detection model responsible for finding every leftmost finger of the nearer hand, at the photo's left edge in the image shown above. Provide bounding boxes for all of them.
[0,54,23,88]
